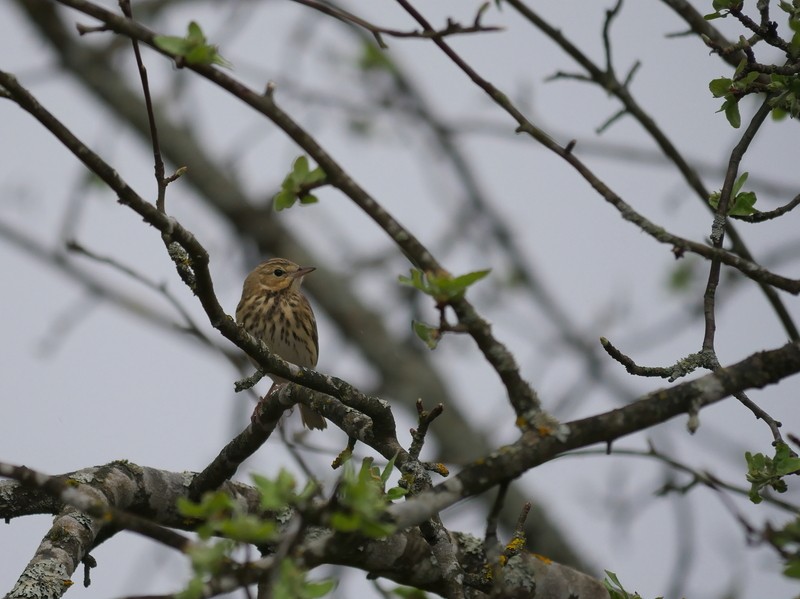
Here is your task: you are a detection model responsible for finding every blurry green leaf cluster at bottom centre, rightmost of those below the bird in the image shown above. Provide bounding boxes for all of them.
[330,458,407,538]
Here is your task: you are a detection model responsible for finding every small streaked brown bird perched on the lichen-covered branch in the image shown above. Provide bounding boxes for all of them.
[236,258,327,429]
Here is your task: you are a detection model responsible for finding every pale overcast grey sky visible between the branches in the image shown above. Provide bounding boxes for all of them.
[0,0,800,599]
